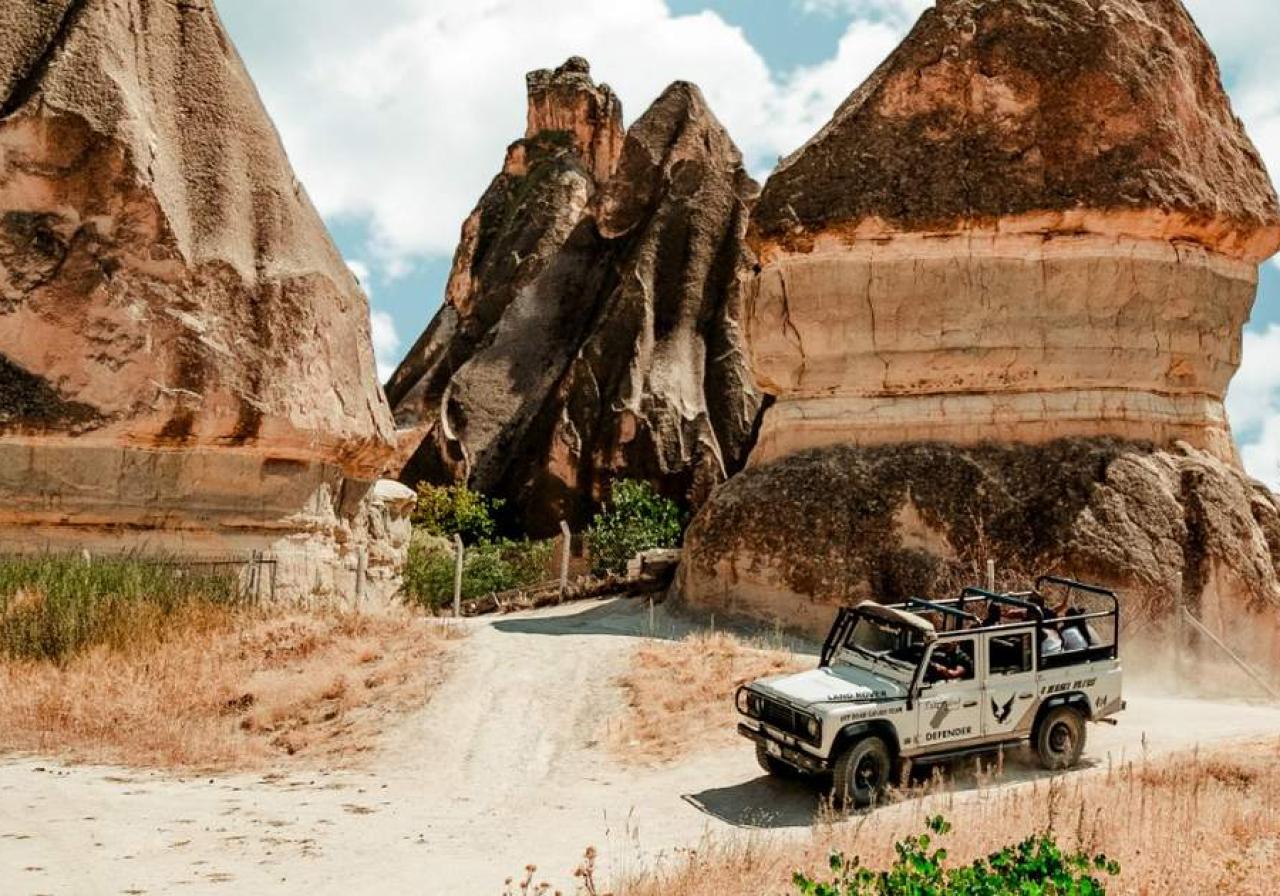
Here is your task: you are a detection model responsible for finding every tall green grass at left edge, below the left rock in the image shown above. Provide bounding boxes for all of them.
[0,554,241,662]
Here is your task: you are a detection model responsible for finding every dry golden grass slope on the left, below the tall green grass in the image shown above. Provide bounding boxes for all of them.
[0,605,451,769]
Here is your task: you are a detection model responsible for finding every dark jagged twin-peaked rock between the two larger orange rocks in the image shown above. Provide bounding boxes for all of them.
[387,58,759,534]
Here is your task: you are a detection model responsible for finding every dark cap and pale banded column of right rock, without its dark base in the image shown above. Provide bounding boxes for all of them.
[748,0,1280,462]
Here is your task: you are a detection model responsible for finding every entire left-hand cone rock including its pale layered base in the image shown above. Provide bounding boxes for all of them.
[0,0,403,601]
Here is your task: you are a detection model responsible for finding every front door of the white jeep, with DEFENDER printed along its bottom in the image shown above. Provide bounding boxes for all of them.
[916,637,983,753]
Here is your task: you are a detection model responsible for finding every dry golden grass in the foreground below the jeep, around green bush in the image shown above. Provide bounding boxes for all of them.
[616,742,1280,896]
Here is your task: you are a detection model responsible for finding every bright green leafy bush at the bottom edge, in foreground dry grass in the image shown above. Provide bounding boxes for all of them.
[794,815,1120,896]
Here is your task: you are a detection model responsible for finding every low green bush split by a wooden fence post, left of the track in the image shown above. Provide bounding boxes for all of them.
[403,532,554,609]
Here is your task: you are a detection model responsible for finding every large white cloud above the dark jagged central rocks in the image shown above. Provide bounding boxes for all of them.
[219,0,920,276]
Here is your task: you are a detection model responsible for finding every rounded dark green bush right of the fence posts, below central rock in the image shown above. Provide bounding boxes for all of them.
[586,479,685,573]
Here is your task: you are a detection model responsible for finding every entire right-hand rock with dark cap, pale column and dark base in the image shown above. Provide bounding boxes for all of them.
[682,0,1280,655]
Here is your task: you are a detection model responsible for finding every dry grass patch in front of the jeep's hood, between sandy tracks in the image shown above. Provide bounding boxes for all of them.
[605,634,815,763]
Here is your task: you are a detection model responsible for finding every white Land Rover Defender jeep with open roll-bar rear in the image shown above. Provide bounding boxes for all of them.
[736,576,1124,806]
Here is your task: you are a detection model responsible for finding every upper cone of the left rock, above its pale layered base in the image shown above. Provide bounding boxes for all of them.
[0,0,394,476]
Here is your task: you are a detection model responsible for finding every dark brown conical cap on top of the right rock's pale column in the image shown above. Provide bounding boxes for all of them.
[753,0,1280,261]
